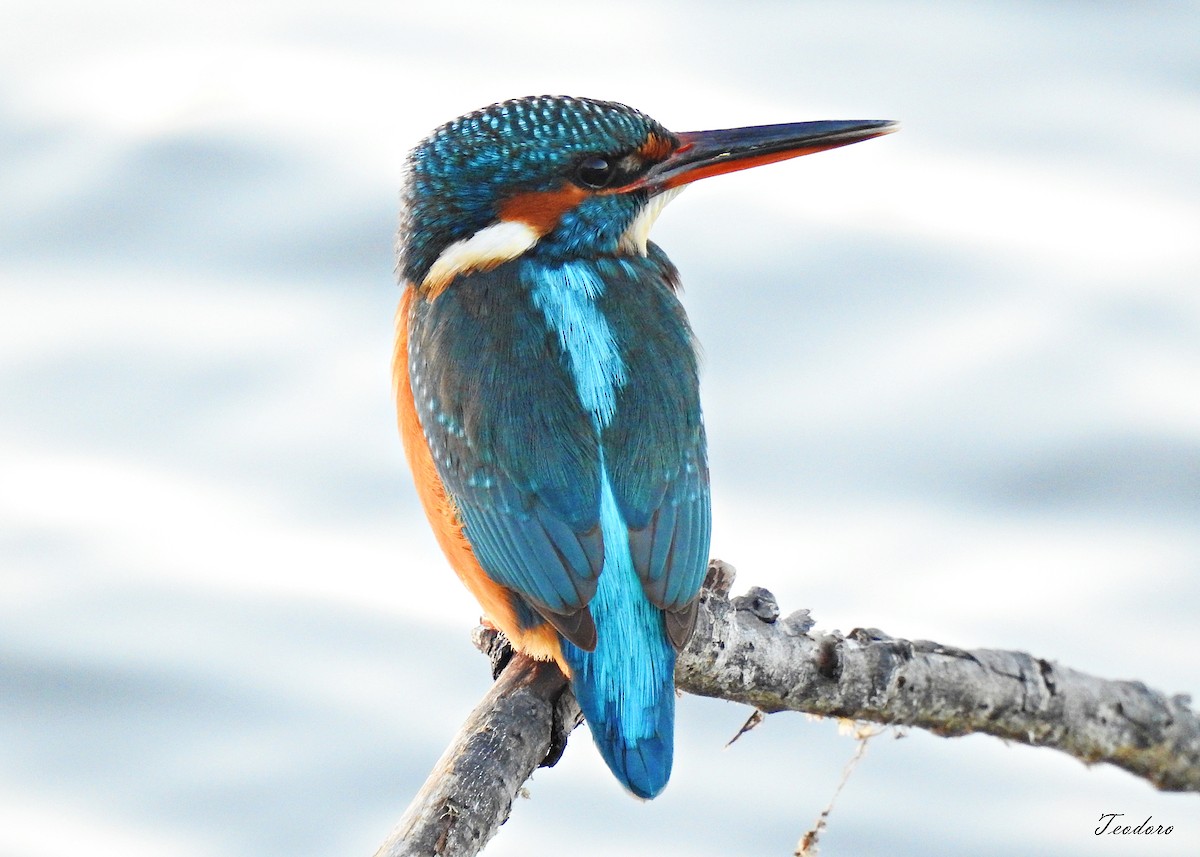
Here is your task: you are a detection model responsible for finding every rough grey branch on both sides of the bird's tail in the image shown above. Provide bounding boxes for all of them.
[376,561,1200,857]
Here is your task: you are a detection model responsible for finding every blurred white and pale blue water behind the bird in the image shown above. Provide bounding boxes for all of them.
[0,0,1200,857]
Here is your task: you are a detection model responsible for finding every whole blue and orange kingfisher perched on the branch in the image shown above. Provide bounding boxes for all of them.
[392,96,896,799]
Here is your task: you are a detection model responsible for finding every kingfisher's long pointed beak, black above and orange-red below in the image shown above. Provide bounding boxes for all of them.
[634,119,900,193]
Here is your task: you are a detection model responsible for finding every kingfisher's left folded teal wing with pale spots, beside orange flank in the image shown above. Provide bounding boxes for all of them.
[409,265,604,649]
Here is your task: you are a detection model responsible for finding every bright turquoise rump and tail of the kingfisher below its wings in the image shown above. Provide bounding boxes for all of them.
[563,468,676,798]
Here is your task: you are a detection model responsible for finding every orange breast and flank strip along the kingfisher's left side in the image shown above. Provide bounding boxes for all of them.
[391,287,570,675]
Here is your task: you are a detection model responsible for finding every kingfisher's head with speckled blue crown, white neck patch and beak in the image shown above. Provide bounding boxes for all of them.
[400,96,895,295]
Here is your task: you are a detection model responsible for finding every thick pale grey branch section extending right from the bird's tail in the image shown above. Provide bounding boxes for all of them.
[676,563,1200,791]
